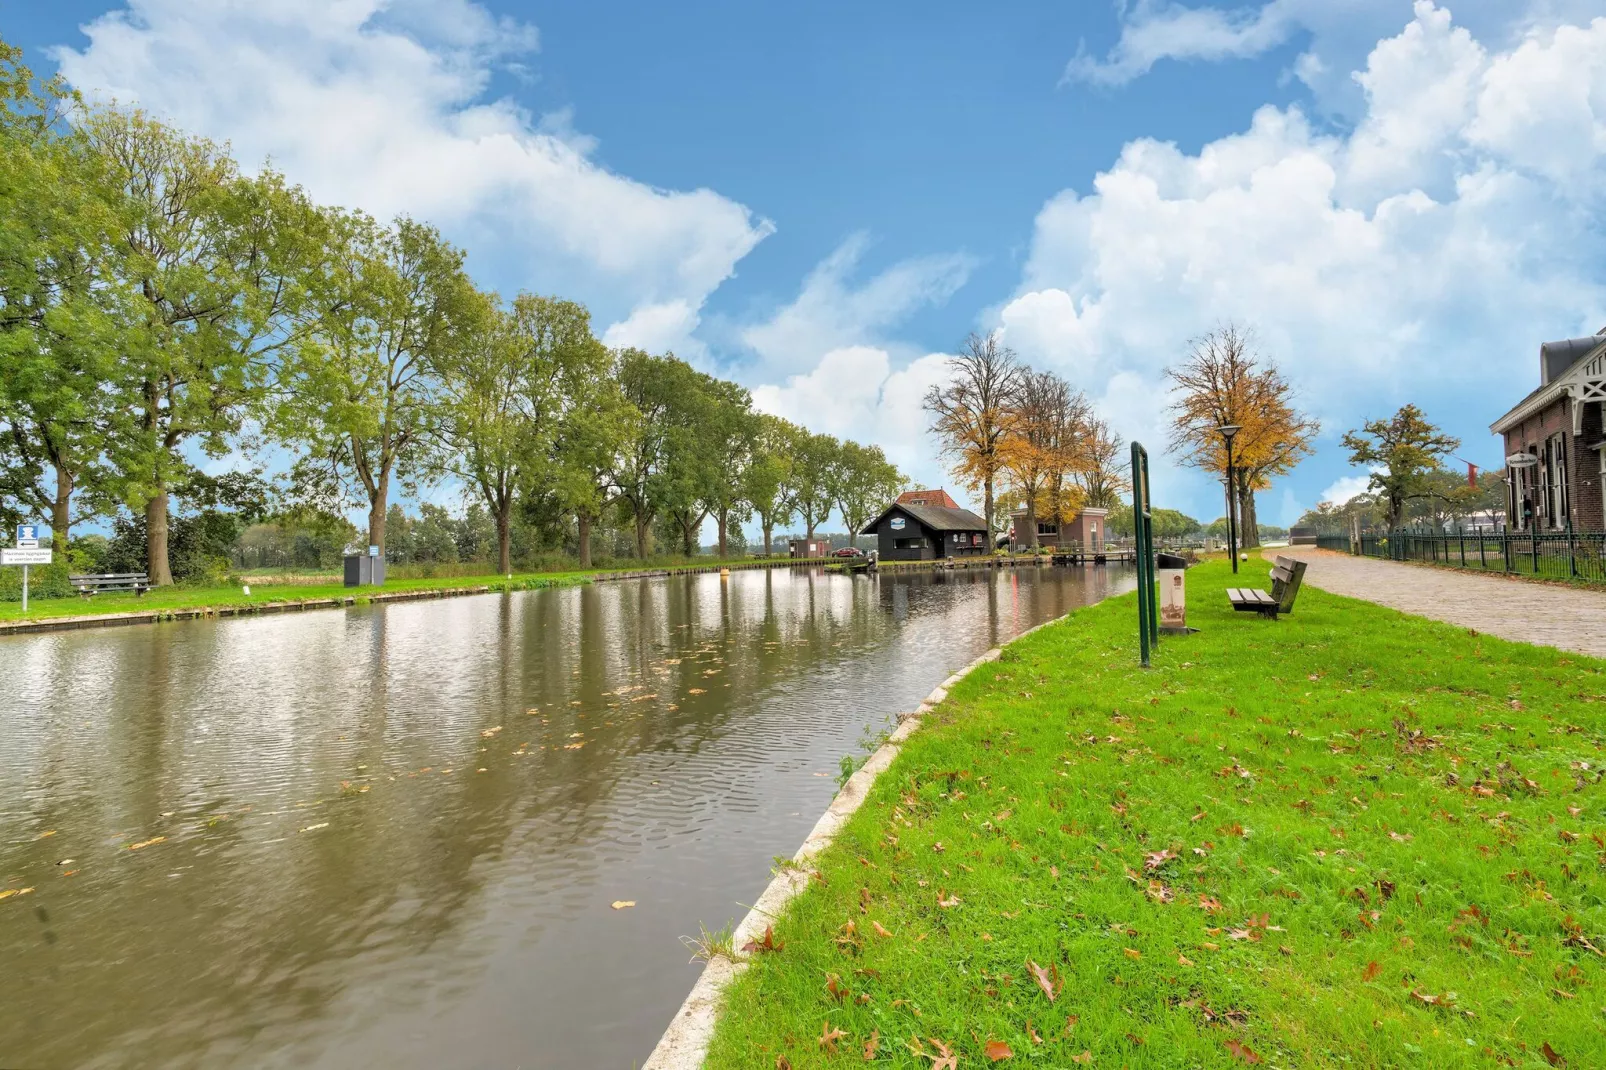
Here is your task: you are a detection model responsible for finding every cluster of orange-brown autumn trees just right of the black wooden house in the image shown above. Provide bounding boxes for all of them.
[925,334,1131,548]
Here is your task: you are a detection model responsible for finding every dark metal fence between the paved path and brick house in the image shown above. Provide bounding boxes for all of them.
[1317,532,1606,583]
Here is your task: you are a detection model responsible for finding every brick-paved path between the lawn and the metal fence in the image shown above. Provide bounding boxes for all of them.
[1267,546,1606,657]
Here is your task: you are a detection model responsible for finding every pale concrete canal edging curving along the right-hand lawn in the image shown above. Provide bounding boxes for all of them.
[641,614,1070,1070]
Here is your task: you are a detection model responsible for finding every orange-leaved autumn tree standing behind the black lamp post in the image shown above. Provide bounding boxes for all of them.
[1166,323,1320,546]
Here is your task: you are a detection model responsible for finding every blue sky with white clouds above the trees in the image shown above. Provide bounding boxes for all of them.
[0,0,1606,524]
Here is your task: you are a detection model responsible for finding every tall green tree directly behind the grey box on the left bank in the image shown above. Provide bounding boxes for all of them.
[278,212,487,553]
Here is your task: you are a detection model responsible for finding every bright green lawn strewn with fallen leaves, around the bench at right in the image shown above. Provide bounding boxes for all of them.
[708,561,1606,1070]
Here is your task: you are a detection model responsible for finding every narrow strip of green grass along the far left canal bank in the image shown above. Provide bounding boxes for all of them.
[0,557,764,622]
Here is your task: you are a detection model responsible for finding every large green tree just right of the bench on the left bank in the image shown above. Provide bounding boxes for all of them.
[80,109,323,585]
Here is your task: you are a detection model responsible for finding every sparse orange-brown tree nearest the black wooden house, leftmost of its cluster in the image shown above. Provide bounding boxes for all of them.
[925,334,1023,541]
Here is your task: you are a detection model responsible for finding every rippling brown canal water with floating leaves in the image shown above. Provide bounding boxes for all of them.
[0,567,1134,1070]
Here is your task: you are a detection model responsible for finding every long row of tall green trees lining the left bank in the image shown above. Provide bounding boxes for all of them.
[0,42,904,583]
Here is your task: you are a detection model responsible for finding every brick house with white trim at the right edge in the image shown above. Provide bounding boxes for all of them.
[1489,328,1606,532]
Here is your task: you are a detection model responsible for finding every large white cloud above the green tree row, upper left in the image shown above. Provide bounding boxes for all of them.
[56,0,772,339]
